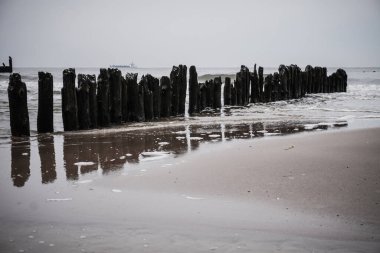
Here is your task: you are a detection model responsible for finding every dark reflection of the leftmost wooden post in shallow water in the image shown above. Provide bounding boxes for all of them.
[11,138,30,187]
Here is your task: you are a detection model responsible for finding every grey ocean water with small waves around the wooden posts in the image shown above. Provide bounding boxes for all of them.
[0,67,380,140]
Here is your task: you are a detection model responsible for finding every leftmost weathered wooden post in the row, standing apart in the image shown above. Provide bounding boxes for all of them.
[8,73,30,136]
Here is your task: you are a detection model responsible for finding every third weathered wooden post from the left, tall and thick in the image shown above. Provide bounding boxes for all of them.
[61,68,78,131]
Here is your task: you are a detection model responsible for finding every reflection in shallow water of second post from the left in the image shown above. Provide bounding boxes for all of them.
[38,135,57,184]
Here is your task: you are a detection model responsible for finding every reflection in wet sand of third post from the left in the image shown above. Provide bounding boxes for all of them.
[63,136,81,180]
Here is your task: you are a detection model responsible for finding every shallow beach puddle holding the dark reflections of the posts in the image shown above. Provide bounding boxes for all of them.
[3,121,347,187]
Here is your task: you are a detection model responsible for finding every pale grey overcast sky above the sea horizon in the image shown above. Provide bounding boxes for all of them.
[0,0,380,67]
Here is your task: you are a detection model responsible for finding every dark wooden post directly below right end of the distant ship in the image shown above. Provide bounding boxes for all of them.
[125,73,139,121]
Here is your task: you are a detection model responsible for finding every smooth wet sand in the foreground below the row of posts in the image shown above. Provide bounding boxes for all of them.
[0,128,380,252]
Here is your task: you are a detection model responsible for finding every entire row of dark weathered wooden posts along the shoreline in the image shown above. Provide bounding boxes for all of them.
[8,65,347,136]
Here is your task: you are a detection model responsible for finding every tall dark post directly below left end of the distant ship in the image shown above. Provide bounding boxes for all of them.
[108,69,121,124]
